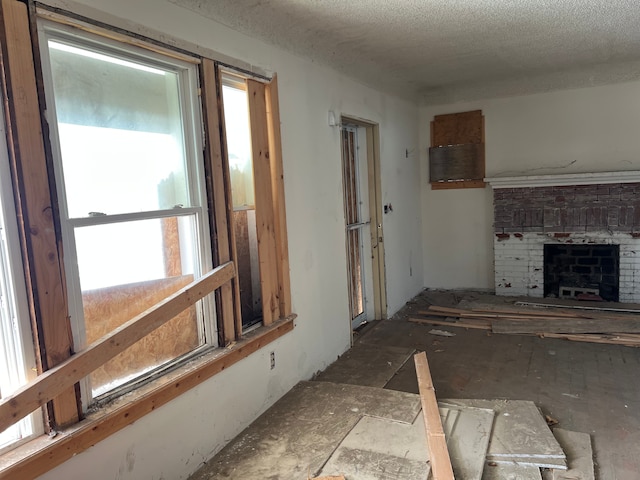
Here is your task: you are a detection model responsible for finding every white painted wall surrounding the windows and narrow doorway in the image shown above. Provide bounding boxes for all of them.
[41,0,423,480]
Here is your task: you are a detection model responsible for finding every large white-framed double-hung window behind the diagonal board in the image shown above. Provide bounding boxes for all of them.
[41,24,216,402]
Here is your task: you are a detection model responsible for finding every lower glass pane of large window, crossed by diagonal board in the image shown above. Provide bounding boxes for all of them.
[75,216,204,397]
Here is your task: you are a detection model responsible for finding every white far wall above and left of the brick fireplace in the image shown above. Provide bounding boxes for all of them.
[420,82,640,289]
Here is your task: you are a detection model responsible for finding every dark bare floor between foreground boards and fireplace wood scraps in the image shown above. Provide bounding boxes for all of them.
[193,291,640,480]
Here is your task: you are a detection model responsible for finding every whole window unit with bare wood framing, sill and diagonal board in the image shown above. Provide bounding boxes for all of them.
[0,0,295,478]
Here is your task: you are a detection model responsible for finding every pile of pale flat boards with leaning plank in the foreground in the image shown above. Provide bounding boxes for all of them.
[412,352,595,480]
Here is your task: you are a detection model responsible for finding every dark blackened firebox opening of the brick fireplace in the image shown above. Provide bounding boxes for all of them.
[544,244,620,302]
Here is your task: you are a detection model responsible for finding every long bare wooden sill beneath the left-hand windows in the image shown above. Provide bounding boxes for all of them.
[0,314,296,480]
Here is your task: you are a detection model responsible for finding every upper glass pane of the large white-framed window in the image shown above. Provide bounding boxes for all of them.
[48,40,189,218]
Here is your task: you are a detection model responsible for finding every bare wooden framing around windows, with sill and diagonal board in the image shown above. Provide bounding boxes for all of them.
[0,0,296,479]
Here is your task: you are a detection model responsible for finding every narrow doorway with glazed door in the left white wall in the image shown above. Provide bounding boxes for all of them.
[340,117,387,329]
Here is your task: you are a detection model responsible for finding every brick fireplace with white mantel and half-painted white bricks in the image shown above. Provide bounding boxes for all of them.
[486,172,640,302]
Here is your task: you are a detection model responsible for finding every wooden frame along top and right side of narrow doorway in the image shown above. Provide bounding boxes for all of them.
[340,115,387,320]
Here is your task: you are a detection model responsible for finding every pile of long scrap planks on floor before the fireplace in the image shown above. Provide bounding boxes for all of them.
[409,302,640,347]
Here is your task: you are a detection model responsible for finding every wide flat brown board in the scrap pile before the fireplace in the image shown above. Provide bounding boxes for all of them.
[491,318,640,334]
